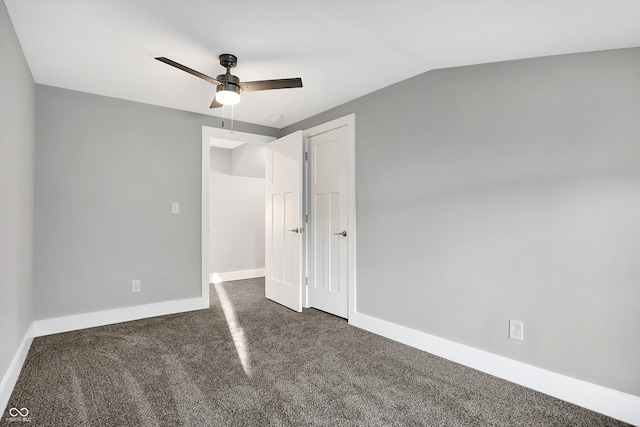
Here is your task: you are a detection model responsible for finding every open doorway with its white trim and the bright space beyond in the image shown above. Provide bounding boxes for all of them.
[201,126,275,301]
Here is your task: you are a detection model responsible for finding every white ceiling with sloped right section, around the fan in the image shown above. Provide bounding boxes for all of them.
[4,0,640,128]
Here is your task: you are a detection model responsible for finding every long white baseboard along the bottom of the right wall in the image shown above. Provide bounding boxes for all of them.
[349,312,640,426]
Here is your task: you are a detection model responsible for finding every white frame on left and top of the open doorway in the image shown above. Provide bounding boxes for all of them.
[200,126,276,307]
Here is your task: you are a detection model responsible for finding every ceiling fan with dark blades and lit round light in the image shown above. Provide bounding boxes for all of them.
[156,53,302,108]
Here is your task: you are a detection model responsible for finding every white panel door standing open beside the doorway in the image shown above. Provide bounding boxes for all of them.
[265,131,303,311]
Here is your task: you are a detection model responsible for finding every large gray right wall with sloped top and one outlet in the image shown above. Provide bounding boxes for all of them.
[282,49,640,396]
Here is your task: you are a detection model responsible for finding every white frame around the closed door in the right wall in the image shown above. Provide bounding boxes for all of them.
[302,113,356,319]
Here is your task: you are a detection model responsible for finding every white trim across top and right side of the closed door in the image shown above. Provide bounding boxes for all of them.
[302,113,356,319]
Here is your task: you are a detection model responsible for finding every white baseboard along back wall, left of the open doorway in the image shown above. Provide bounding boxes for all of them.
[33,296,209,337]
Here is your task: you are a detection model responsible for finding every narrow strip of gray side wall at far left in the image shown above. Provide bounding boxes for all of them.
[0,1,35,388]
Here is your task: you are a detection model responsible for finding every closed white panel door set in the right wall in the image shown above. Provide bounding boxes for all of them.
[308,126,349,318]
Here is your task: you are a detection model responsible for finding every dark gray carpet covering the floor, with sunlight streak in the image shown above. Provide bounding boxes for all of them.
[0,279,624,427]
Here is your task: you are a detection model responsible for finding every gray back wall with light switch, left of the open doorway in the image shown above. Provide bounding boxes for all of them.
[34,85,278,319]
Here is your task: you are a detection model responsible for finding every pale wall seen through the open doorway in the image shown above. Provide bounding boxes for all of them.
[209,144,265,273]
